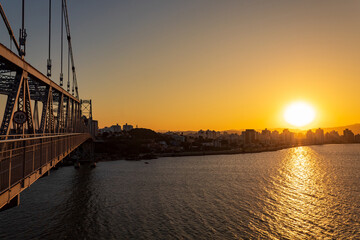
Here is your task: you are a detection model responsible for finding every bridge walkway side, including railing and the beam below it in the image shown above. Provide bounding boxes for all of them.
[0,133,91,210]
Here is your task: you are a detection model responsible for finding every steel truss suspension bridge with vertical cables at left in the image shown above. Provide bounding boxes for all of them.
[0,0,93,210]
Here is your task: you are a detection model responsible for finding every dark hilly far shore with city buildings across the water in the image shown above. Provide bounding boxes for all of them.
[95,124,360,157]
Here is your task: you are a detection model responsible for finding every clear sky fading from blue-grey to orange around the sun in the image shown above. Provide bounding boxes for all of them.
[0,0,360,130]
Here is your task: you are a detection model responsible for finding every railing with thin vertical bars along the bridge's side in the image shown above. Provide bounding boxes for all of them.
[0,133,90,194]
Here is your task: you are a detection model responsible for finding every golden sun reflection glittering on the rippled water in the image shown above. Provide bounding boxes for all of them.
[250,147,352,239]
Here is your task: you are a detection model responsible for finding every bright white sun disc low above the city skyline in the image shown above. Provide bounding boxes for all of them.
[284,102,315,127]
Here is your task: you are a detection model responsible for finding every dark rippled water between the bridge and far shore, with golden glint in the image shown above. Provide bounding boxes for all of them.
[0,145,360,239]
